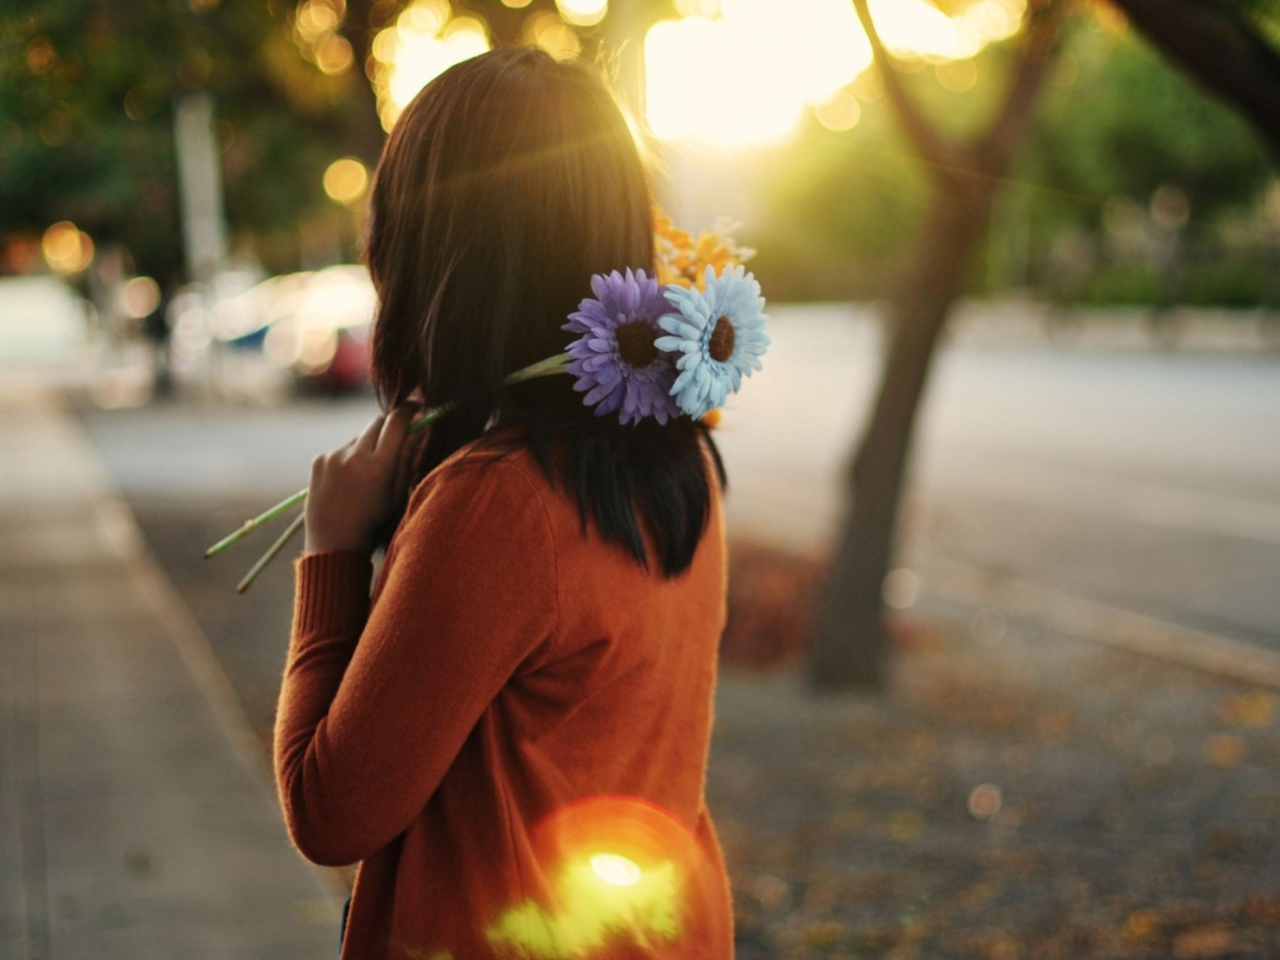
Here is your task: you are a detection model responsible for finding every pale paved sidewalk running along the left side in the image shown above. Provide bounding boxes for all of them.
[0,371,339,960]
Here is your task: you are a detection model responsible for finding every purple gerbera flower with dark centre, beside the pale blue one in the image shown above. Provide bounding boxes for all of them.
[561,270,680,424]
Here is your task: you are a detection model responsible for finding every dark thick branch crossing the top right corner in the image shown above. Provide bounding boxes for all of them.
[1111,0,1280,165]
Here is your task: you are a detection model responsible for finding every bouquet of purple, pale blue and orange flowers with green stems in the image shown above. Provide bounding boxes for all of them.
[205,211,769,593]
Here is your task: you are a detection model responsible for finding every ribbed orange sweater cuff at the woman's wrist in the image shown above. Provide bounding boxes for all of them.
[293,552,374,640]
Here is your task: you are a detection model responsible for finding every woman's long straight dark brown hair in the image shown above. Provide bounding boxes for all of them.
[366,47,723,576]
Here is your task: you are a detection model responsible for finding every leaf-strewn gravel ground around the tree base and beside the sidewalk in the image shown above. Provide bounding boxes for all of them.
[132,498,1280,960]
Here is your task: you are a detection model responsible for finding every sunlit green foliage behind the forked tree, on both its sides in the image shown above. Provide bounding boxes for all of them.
[754,15,1280,303]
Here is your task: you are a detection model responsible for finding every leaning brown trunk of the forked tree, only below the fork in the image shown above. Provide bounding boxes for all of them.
[812,174,993,690]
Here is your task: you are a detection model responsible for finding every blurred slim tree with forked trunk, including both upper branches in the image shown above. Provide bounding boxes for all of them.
[812,0,1062,689]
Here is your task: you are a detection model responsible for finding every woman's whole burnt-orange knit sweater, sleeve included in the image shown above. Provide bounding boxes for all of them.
[275,448,733,960]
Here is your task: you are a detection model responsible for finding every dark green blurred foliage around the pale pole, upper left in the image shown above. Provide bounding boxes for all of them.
[0,0,364,278]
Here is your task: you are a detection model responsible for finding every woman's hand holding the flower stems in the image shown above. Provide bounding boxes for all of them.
[303,406,415,556]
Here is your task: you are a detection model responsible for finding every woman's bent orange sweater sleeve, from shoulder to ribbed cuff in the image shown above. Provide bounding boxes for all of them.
[275,461,557,865]
